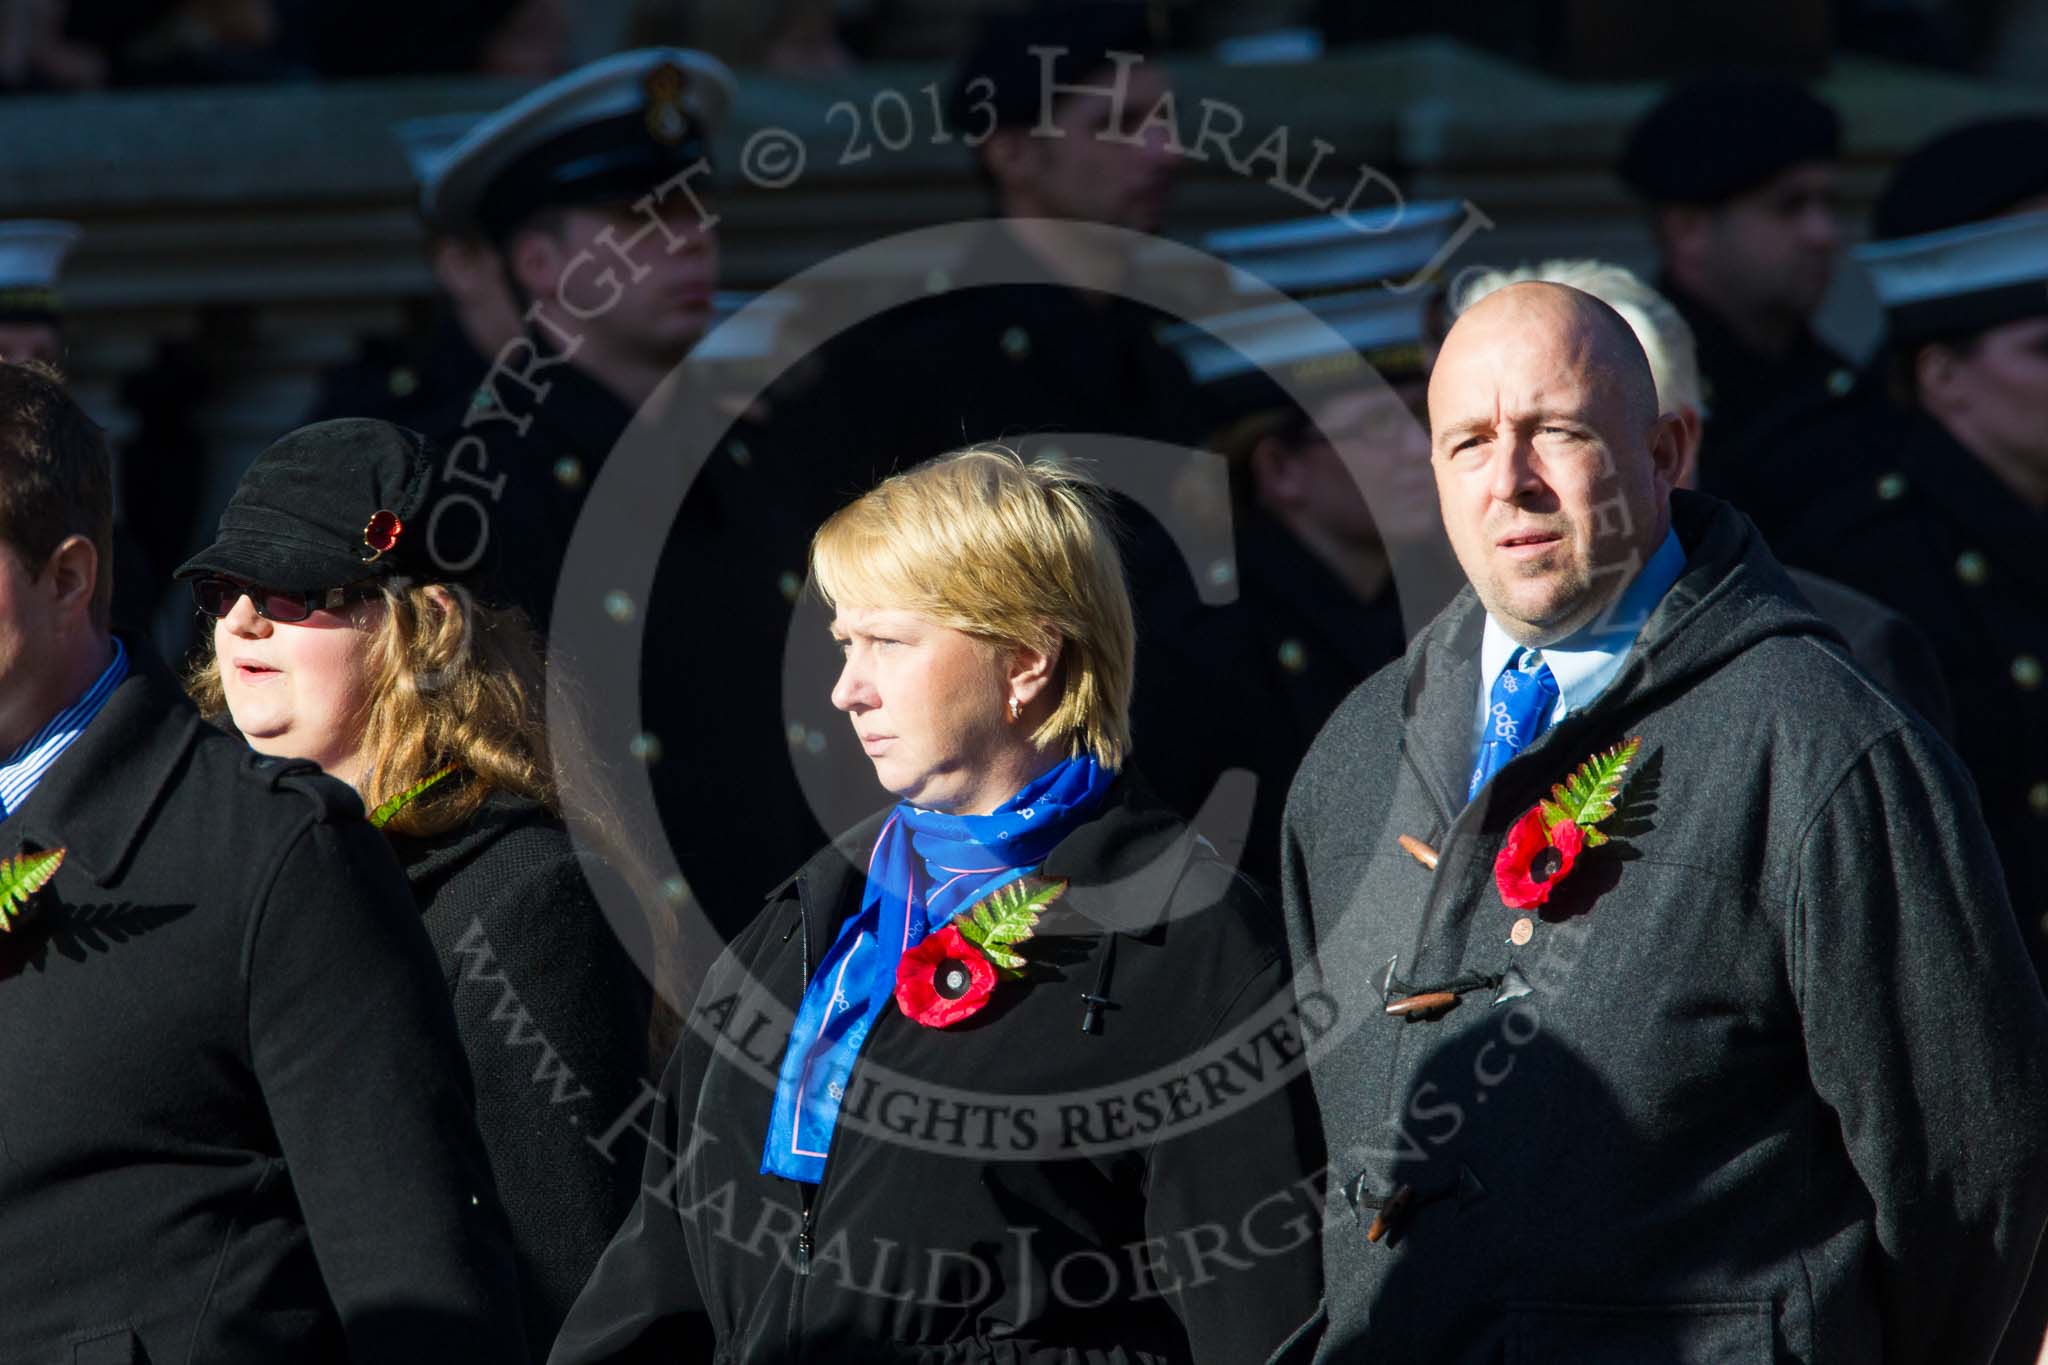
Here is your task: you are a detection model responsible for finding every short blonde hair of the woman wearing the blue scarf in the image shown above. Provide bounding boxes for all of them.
[811,448,1137,769]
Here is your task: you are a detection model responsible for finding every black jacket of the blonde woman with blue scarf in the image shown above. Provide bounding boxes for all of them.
[549,776,1315,1365]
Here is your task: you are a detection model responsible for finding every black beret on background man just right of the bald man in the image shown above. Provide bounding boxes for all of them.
[1616,76,1841,205]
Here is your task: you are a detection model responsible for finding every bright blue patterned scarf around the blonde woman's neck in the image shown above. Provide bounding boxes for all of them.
[762,757,1116,1185]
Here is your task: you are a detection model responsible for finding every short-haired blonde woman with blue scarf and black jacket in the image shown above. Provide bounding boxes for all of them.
[551,450,1319,1365]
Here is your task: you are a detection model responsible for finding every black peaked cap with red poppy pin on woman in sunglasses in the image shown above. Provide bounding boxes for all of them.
[176,417,473,591]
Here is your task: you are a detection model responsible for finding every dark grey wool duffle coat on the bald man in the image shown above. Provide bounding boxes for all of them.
[1282,493,2048,1365]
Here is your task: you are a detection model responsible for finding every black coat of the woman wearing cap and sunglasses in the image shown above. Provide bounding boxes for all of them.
[399,796,649,1359]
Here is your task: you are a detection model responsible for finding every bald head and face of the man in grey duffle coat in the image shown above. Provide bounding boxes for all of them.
[1430,282,1679,645]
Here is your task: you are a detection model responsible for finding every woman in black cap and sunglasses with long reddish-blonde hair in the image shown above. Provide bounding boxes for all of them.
[178,420,649,1359]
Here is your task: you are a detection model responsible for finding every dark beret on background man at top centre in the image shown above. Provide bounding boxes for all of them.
[952,0,1157,135]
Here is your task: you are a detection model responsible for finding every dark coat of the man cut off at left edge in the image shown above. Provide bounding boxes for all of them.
[0,639,526,1365]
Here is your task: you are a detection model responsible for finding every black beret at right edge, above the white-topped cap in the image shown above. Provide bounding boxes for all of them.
[1870,115,2048,239]
